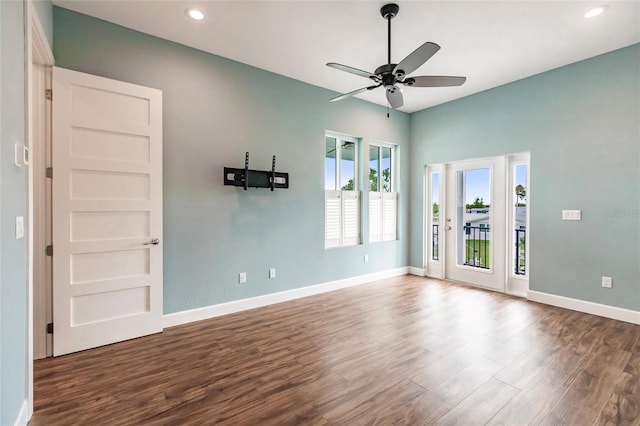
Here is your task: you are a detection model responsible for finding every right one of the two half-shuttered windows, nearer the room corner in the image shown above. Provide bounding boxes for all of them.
[369,144,398,242]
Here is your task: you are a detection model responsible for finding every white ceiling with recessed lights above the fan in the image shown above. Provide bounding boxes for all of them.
[53,0,640,112]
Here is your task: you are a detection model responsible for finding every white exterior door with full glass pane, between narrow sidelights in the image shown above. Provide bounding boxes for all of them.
[440,157,507,291]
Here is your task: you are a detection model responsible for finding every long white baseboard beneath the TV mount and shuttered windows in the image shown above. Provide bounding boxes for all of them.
[162,267,409,328]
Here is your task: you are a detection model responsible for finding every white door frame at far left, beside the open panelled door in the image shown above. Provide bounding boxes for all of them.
[25,0,54,419]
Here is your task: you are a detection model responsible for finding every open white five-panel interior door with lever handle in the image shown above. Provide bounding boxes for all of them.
[52,68,162,356]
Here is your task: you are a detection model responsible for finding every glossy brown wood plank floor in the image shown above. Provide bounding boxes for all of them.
[29,275,640,426]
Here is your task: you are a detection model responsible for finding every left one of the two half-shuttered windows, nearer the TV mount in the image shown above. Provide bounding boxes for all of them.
[324,134,360,248]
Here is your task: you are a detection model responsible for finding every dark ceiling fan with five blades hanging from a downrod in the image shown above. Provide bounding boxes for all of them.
[327,3,467,109]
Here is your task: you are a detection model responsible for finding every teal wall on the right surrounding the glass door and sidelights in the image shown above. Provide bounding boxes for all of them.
[410,44,640,310]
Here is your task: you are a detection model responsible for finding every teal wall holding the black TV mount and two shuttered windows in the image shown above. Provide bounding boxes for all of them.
[54,7,409,313]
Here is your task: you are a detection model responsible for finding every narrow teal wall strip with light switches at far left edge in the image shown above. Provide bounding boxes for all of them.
[0,1,28,425]
